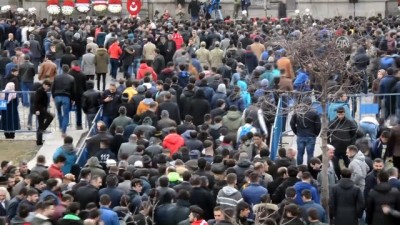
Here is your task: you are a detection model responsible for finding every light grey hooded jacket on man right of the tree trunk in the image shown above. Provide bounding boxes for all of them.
[349,151,369,191]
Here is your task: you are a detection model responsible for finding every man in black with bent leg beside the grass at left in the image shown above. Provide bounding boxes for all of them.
[34,80,54,145]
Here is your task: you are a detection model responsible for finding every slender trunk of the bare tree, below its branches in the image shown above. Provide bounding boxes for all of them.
[321,82,329,220]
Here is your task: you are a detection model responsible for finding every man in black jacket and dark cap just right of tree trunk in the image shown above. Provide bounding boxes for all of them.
[328,106,357,166]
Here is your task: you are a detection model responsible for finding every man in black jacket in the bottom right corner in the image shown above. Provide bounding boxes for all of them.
[365,171,400,225]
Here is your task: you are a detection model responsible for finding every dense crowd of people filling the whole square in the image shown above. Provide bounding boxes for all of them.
[0,7,400,225]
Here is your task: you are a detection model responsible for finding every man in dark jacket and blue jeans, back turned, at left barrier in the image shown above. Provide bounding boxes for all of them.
[51,65,75,137]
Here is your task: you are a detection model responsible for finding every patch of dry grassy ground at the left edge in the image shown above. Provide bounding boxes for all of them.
[0,140,40,165]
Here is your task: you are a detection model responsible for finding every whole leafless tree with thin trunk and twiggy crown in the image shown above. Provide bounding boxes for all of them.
[280,29,359,216]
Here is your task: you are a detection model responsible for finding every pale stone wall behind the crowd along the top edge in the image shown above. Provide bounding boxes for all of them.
[0,0,396,18]
